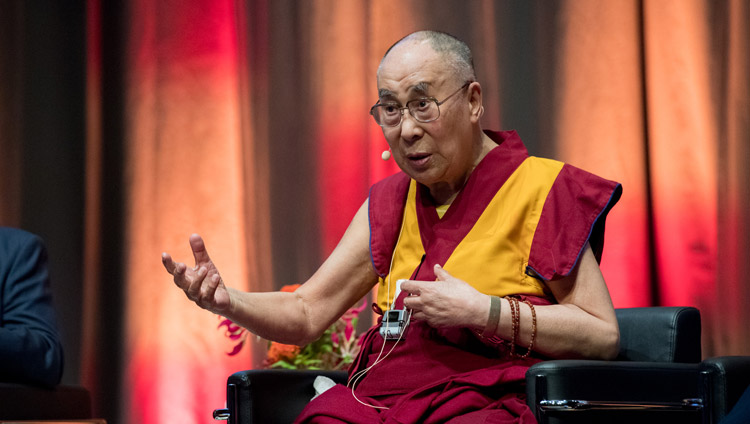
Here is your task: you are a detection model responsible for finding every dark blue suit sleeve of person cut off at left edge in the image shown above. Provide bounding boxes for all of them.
[0,227,63,387]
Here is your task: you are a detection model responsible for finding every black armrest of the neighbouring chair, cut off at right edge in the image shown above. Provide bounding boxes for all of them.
[701,356,750,422]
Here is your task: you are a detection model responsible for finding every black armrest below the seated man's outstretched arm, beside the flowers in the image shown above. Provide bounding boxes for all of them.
[227,369,347,424]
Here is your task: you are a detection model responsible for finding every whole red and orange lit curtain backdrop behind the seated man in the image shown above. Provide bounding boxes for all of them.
[0,0,750,424]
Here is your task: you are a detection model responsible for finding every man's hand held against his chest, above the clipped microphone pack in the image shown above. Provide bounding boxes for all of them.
[401,265,490,329]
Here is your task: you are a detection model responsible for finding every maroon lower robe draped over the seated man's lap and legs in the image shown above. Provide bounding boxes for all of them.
[295,297,550,424]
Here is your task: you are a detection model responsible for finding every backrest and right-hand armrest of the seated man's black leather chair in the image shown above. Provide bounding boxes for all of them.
[526,307,707,423]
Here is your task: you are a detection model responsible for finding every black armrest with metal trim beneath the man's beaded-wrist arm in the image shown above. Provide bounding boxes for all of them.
[526,360,703,423]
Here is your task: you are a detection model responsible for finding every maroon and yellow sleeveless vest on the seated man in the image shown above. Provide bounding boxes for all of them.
[369,131,622,310]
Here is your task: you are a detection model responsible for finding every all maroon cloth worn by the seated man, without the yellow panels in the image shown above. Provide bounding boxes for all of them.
[296,131,621,424]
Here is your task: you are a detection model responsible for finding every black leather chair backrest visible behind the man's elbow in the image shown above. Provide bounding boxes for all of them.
[615,306,701,363]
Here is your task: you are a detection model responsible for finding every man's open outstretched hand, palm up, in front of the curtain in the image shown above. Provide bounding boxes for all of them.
[161,234,231,314]
